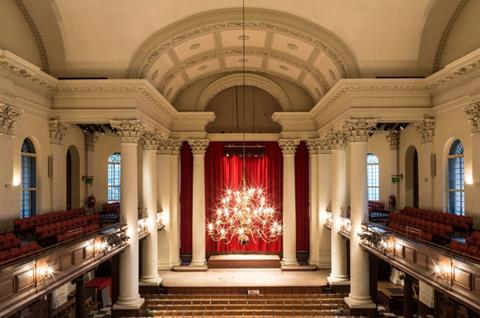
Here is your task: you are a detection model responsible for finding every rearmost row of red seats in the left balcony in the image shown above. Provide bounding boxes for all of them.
[13,208,85,233]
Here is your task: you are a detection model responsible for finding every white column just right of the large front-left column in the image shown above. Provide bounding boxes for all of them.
[140,132,162,286]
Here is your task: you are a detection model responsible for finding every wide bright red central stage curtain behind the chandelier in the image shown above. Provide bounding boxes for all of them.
[205,142,283,255]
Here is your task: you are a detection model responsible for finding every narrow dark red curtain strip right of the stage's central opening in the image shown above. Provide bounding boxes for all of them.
[295,141,310,252]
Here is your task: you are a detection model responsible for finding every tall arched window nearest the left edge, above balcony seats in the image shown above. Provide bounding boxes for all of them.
[20,138,37,218]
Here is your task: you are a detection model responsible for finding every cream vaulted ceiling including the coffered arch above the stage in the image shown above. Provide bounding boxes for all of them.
[12,0,469,107]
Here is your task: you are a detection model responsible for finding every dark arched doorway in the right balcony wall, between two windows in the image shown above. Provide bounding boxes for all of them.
[405,146,419,208]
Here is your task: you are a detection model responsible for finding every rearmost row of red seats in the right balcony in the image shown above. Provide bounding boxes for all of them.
[402,207,473,231]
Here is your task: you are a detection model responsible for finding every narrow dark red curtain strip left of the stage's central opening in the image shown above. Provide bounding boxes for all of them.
[180,142,193,254]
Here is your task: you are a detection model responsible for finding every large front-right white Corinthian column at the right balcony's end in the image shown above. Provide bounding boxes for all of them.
[344,119,376,308]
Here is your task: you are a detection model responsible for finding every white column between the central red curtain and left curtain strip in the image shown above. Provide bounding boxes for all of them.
[188,139,209,266]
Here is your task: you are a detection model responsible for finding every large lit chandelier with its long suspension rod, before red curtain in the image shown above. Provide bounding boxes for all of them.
[207,0,282,245]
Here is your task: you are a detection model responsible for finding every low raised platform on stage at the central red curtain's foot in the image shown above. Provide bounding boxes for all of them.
[208,254,281,268]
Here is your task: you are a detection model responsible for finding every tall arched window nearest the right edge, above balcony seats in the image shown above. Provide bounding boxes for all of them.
[448,139,465,215]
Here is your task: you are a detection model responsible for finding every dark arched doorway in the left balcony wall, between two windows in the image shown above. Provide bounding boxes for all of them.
[66,146,80,210]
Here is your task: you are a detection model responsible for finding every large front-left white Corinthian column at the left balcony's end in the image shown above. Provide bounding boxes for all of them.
[110,120,144,310]
